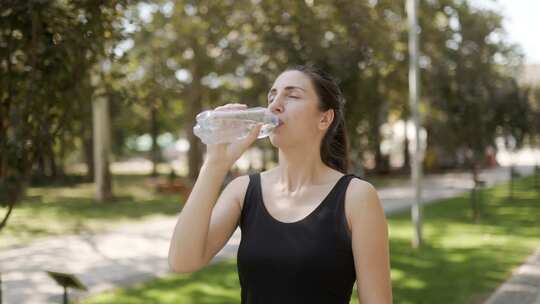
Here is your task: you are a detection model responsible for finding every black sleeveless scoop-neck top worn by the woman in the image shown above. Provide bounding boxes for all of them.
[237,173,356,304]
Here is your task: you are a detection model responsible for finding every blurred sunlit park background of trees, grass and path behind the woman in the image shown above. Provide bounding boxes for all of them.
[0,0,540,303]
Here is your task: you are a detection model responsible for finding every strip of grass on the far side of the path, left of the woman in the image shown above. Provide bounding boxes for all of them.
[0,176,183,248]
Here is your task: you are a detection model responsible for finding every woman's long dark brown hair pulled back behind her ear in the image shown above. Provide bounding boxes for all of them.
[286,65,350,174]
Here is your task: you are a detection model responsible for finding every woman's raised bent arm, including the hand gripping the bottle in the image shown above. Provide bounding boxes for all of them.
[168,104,262,272]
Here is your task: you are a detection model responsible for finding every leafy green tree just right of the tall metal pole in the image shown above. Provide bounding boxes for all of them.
[423,1,529,219]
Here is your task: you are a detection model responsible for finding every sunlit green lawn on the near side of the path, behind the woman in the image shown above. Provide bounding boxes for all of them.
[81,178,540,304]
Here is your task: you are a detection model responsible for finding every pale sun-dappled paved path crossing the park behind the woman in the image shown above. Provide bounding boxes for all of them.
[0,167,538,304]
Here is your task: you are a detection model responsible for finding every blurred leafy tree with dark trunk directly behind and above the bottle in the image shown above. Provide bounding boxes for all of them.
[123,1,258,180]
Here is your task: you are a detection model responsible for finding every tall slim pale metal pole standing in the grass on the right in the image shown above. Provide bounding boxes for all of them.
[407,0,422,248]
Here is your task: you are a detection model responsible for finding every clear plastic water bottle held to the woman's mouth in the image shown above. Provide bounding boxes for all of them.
[193,107,279,145]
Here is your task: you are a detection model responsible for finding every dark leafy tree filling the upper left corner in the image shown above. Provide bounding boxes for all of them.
[0,0,126,229]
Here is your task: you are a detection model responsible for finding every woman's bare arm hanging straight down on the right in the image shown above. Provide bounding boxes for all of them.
[347,179,392,304]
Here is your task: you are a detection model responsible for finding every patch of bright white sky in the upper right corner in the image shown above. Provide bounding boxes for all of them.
[471,0,540,64]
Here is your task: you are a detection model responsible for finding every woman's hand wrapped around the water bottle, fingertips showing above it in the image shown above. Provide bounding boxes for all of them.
[206,103,263,169]
